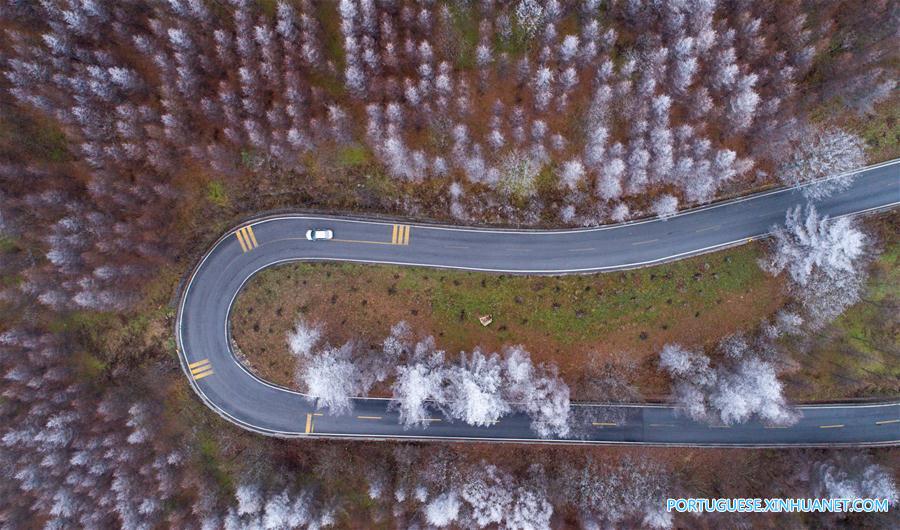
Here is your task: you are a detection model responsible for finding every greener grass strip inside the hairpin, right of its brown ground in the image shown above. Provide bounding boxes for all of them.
[408,243,763,344]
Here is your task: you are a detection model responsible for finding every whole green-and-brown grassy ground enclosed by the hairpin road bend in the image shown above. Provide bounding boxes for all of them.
[232,244,785,395]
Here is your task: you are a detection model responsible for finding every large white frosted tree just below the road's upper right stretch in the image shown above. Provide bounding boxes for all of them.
[762,205,868,328]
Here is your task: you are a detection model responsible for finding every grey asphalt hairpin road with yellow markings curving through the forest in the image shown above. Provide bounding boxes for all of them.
[176,160,900,446]
